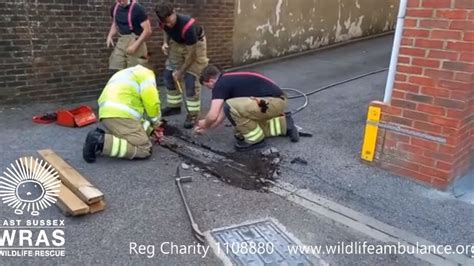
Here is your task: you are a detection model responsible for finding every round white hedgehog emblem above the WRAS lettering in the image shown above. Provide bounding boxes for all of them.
[0,157,61,216]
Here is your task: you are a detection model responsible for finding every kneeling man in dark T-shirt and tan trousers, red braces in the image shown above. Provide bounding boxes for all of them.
[194,66,299,151]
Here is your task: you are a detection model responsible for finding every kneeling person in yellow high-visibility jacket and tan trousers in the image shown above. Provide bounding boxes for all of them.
[83,65,162,163]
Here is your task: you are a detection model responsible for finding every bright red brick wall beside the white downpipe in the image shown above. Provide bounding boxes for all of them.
[372,0,474,189]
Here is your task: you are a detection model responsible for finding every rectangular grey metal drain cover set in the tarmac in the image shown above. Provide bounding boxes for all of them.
[211,220,313,266]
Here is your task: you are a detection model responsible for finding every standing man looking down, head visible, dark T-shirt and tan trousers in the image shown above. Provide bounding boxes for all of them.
[155,1,209,128]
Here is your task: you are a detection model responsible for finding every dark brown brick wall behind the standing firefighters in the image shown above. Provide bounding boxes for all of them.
[0,0,234,104]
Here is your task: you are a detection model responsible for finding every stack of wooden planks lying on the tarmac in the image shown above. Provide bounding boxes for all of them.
[24,150,106,216]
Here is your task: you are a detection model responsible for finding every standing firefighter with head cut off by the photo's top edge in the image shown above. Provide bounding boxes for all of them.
[107,0,151,72]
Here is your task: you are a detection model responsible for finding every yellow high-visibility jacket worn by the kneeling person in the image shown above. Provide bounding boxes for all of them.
[98,65,161,124]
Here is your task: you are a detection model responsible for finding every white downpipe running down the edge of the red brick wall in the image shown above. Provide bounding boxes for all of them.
[383,0,408,103]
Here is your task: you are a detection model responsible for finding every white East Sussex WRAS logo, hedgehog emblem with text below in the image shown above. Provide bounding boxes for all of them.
[0,157,65,257]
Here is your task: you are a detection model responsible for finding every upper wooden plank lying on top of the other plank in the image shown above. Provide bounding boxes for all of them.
[38,150,104,204]
